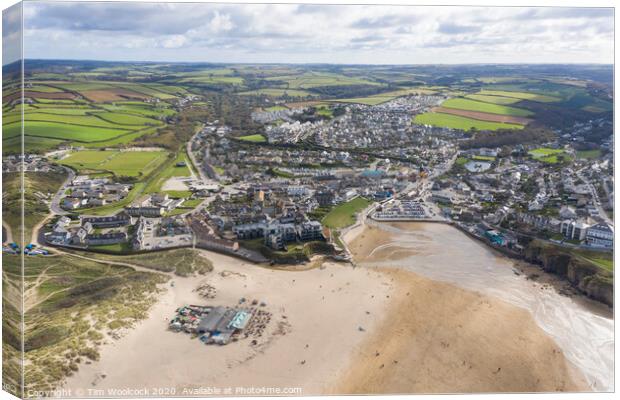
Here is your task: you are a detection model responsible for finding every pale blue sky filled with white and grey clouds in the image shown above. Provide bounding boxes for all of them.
[3,2,614,64]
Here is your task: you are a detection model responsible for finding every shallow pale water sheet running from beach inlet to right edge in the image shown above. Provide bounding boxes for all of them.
[360,223,614,391]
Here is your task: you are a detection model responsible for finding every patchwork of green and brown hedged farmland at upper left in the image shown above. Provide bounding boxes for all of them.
[2,81,182,152]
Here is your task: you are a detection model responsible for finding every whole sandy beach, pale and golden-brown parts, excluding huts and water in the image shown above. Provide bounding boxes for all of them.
[64,220,604,396]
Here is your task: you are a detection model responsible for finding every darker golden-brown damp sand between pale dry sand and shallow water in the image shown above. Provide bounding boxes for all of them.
[331,270,587,394]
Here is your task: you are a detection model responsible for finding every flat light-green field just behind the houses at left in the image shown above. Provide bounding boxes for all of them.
[58,150,167,177]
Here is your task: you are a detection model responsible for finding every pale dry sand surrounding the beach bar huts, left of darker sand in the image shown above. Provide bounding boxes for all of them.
[64,253,394,396]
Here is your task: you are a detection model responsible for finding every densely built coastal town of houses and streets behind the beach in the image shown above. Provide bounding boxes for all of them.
[3,95,613,268]
